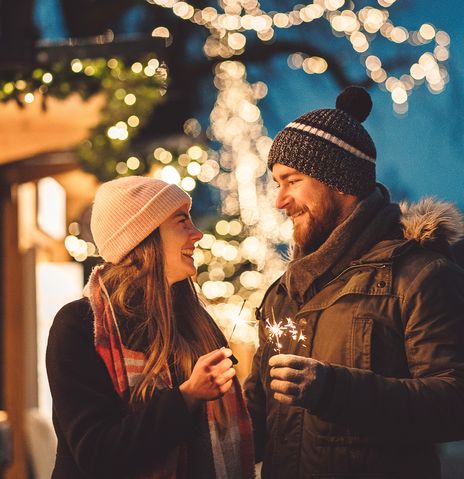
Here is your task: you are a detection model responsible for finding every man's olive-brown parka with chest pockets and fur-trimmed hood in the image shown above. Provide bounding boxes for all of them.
[245,189,464,479]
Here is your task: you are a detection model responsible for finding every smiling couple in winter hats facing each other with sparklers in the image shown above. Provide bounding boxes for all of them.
[47,87,464,479]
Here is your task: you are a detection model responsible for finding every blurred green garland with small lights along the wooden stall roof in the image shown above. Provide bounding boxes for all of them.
[0,58,167,181]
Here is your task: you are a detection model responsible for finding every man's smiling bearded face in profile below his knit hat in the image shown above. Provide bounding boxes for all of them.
[272,163,343,254]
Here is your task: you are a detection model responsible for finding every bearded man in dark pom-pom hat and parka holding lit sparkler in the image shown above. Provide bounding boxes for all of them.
[245,87,464,479]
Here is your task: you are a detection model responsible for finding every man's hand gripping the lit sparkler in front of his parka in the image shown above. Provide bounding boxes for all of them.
[269,354,327,412]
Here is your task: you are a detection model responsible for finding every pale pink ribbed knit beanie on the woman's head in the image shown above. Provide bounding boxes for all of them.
[90,176,192,263]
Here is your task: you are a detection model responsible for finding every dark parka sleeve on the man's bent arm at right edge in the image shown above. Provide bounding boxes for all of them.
[313,259,464,442]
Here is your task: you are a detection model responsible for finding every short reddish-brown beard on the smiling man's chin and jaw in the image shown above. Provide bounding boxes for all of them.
[293,202,340,254]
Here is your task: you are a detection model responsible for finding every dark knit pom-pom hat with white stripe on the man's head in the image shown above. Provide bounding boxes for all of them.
[268,86,377,197]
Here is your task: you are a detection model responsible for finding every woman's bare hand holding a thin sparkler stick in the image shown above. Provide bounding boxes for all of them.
[179,348,235,409]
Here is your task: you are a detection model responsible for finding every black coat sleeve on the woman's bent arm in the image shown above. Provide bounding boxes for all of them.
[46,300,197,478]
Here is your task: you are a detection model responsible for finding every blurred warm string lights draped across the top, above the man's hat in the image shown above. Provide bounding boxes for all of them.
[148,0,449,110]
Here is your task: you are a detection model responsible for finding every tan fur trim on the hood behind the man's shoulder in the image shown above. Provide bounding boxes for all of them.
[400,197,464,246]
